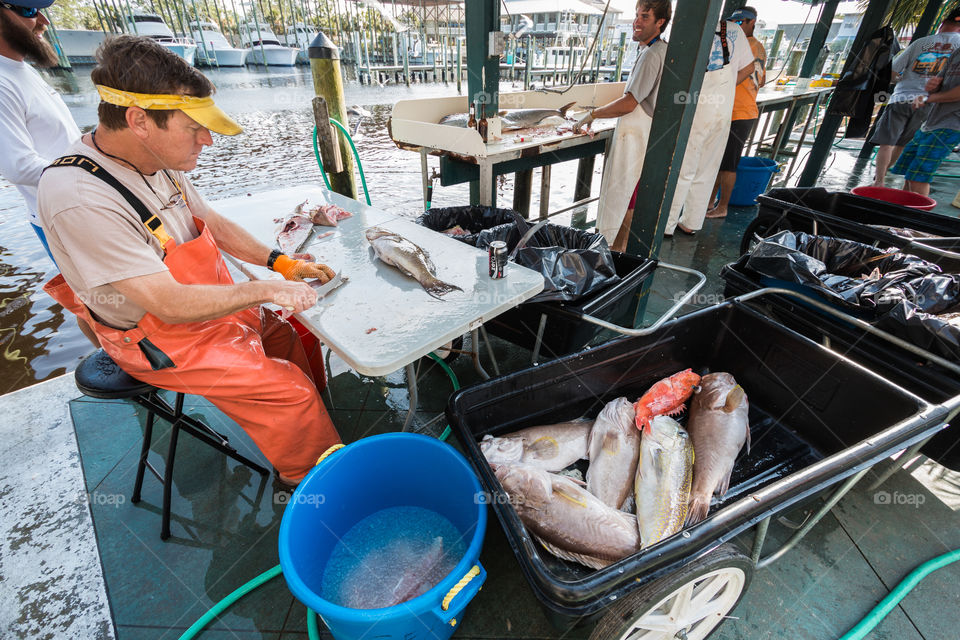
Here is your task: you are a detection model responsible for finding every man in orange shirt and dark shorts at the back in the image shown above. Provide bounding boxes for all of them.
[706,7,767,218]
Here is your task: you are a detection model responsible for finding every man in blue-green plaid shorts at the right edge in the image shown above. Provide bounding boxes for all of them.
[890,40,960,196]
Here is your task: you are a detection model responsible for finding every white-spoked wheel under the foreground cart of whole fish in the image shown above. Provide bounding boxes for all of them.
[590,544,753,640]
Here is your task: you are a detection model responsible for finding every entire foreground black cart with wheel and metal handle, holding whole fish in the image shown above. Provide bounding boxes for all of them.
[447,289,960,640]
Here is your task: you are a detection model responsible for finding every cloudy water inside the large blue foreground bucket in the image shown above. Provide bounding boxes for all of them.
[320,507,467,609]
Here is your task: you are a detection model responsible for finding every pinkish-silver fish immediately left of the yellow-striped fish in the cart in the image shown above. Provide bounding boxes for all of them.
[587,398,640,509]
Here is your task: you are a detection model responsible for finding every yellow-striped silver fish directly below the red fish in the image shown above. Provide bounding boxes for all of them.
[634,416,693,548]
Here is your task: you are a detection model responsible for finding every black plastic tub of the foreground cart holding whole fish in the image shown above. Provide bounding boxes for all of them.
[447,302,949,629]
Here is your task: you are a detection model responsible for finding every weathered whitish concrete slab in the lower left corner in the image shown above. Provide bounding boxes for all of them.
[0,375,116,640]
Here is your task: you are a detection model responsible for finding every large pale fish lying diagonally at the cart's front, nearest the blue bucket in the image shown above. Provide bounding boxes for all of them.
[491,464,640,569]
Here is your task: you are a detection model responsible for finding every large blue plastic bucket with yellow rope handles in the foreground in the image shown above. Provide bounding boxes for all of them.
[280,433,487,640]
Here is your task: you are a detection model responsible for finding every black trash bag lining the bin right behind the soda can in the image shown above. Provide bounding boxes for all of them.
[477,216,620,302]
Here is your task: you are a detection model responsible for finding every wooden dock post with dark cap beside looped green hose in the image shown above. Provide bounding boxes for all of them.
[308,33,357,199]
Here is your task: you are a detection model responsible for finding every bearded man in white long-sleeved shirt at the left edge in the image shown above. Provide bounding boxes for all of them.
[0,0,80,260]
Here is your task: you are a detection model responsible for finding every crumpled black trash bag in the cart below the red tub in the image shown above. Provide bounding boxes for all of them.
[737,231,940,312]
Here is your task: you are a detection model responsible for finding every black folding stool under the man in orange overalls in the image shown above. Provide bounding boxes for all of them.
[74,349,268,540]
